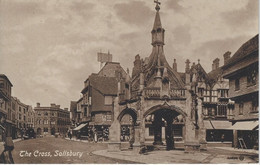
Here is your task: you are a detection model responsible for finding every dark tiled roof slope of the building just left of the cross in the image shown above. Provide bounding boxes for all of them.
[89,75,118,95]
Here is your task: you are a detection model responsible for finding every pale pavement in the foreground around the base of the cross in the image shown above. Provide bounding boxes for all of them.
[93,147,259,164]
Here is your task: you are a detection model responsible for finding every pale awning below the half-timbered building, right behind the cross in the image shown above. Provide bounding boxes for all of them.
[203,120,232,129]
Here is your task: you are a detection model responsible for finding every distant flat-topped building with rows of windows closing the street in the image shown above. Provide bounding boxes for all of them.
[34,103,70,135]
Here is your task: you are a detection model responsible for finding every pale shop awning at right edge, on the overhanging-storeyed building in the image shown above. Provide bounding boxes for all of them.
[228,121,259,130]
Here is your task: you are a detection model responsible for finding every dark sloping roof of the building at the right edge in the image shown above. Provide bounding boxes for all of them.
[223,34,259,68]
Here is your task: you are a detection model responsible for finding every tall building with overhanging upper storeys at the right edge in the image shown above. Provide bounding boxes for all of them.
[223,35,259,148]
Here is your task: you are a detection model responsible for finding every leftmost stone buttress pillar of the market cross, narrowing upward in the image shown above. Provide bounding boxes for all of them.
[108,97,121,152]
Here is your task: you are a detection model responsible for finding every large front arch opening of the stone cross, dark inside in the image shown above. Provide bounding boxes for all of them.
[143,105,187,150]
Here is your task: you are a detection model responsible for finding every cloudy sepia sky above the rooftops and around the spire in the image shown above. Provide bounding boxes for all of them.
[0,0,259,108]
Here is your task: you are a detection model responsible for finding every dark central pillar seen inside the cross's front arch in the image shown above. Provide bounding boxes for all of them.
[153,113,163,145]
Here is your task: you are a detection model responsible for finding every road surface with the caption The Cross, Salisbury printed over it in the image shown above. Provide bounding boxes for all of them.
[13,137,133,164]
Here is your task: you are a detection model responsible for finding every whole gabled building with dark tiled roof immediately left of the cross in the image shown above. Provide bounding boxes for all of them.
[76,62,127,138]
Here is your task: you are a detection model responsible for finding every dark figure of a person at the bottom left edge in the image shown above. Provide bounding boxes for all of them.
[0,115,14,164]
